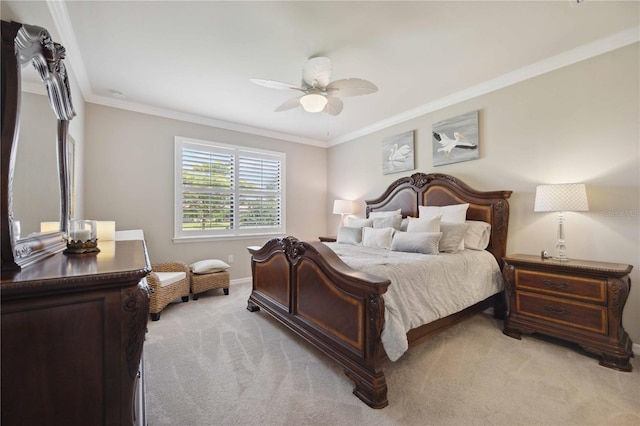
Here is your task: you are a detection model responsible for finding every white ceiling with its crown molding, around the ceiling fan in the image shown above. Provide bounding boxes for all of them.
[2,0,640,146]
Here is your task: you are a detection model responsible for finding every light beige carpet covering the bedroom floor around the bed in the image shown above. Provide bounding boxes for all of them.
[145,283,640,426]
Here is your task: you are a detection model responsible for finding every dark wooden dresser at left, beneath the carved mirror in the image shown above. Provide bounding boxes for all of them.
[1,241,150,425]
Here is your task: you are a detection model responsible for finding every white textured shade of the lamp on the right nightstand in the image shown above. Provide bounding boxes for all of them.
[533,183,589,212]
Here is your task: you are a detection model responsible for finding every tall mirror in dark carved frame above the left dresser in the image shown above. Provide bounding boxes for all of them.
[0,21,75,272]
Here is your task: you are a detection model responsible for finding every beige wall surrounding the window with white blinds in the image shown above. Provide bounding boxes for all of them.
[84,104,327,280]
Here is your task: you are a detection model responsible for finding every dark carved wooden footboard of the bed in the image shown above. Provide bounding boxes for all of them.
[247,237,390,408]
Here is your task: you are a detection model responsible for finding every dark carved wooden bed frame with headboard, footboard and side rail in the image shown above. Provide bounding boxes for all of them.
[247,173,511,408]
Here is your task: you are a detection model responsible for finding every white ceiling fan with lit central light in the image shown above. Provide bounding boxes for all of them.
[251,56,378,115]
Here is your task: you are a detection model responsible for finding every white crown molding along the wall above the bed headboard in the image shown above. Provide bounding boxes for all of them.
[328,26,640,147]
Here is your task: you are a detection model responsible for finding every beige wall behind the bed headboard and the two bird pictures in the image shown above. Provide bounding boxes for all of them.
[327,44,640,344]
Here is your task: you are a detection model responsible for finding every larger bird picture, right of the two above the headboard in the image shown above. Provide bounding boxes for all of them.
[432,111,480,166]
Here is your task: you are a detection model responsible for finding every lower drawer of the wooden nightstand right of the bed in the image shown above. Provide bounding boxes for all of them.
[516,292,608,335]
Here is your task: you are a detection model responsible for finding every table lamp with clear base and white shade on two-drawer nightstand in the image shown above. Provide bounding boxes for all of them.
[533,183,589,261]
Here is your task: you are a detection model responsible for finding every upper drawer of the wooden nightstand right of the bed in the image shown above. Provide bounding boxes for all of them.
[515,269,607,303]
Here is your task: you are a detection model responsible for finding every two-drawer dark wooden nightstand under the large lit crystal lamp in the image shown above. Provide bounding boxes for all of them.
[503,254,633,371]
